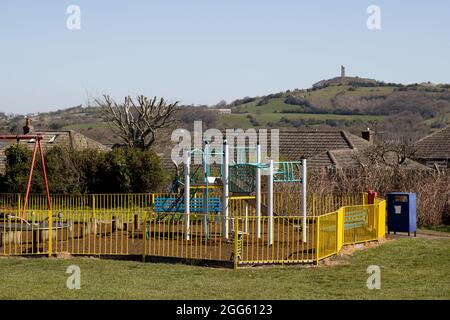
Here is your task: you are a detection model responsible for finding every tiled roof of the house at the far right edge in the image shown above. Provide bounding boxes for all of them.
[415,125,450,159]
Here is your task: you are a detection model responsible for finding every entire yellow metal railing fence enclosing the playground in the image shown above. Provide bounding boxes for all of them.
[0,194,386,266]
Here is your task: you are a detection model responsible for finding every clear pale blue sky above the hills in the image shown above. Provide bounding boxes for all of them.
[0,0,450,113]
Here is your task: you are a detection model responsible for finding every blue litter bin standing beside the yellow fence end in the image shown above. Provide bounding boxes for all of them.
[387,192,417,236]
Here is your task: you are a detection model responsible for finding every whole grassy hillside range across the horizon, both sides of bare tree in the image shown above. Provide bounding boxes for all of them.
[0,77,450,144]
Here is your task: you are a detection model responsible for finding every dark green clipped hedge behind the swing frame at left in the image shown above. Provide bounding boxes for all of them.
[0,145,167,194]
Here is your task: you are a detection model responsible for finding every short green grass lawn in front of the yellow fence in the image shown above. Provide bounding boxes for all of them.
[0,238,450,299]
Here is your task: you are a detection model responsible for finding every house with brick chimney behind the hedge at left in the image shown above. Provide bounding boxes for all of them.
[0,118,109,173]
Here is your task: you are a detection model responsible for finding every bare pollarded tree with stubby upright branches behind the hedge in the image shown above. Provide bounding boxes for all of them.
[95,95,178,150]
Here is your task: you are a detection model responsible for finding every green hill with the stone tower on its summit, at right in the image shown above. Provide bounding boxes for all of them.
[220,78,450,138]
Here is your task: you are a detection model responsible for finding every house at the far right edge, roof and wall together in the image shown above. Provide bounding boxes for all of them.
[414,125,450,170]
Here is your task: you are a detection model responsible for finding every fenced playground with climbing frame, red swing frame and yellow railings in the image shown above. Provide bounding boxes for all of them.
[0,136,386,268]
